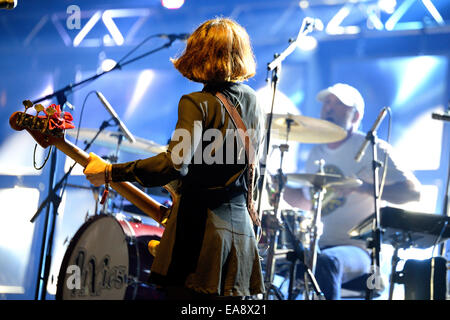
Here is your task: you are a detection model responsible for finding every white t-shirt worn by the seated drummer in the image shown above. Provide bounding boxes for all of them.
[305,132,415,249]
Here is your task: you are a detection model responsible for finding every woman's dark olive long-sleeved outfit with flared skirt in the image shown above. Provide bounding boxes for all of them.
[112,83,264,296]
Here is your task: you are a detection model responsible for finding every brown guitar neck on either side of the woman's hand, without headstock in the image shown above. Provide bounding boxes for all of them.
[54,139,169,223]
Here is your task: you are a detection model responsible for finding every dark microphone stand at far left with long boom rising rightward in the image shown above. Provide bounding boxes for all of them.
[31,37,176,300]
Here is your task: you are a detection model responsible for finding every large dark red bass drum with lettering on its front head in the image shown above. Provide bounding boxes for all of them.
[56,215,164,300]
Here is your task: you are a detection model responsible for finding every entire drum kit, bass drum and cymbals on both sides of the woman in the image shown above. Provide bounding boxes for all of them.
[52,114,361,300]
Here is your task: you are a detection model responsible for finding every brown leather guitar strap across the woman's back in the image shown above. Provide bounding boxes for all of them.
[216,92,261,226]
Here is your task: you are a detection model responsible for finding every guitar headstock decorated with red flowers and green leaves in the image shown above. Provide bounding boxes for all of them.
[9,100,74,148]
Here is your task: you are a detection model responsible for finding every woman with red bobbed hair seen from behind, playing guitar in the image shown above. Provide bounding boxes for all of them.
[84,18,264,299]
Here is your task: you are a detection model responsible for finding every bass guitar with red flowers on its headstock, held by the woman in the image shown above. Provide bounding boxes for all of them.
[9,110,179,224]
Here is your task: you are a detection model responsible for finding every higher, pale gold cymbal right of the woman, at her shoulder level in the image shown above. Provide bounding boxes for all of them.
[271,114,347,143]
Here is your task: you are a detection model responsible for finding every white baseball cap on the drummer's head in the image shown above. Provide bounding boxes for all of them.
[317,83,364,119]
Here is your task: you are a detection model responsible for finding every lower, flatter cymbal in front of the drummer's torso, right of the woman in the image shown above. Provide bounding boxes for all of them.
[286,172,362,188]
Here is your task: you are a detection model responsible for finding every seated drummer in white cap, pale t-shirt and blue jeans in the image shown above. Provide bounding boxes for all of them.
[284,83,420,300]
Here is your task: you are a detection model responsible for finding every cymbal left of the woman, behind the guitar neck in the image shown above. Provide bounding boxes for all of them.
[66,128,167,155]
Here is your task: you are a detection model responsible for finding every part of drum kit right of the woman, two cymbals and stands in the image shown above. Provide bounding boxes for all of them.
[260,114,362,300]
